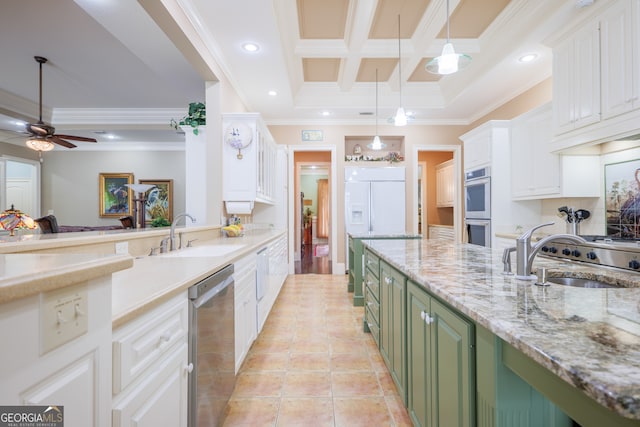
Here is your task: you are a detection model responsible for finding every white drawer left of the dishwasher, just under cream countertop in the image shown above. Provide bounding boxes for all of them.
[112,292,189,394]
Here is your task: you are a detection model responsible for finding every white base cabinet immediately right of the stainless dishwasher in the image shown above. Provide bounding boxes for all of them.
[233,254,258,373]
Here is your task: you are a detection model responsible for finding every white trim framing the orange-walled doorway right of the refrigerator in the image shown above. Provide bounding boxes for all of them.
[411,145,462,243]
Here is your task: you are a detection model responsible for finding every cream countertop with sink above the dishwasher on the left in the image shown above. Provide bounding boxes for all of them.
[111,230,285,329]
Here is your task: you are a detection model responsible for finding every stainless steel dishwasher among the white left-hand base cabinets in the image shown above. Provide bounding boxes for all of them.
[189,265,236,427]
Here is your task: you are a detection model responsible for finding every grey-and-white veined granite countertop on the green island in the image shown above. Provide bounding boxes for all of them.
[365,240,640,419]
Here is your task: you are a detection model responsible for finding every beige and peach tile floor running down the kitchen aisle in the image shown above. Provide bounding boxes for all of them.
[224,274,412,427]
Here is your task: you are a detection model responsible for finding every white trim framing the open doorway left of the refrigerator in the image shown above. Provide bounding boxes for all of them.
[288,145,345,274]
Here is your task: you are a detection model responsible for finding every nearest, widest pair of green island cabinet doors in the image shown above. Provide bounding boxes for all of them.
[407,281,476,427]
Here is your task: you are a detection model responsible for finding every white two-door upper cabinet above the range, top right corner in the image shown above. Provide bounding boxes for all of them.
[551,0,640,152]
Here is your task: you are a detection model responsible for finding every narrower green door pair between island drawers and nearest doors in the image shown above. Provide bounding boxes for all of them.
[380,261,407,405]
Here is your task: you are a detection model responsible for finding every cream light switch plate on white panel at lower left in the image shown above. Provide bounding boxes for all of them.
[40,282,89,354]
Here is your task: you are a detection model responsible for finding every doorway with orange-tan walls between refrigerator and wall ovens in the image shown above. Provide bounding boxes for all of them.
[413,145,462,242]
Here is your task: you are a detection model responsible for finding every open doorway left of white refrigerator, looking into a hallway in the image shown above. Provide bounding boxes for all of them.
[290,147,335,274]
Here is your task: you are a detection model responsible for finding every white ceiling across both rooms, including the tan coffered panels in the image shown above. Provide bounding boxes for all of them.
[0,0,603,149]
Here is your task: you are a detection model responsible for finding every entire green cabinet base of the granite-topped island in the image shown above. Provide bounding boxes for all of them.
[364,248,640,427]
